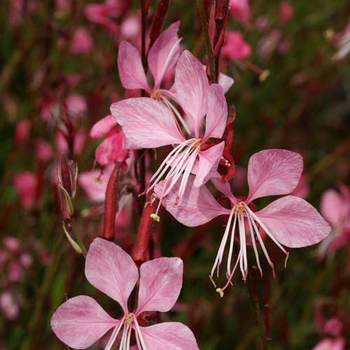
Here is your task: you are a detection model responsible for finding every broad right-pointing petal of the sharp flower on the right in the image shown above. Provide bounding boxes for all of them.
[256,196,331,248]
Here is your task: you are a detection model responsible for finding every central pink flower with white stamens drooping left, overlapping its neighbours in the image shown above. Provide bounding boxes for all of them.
[111,51,227,213]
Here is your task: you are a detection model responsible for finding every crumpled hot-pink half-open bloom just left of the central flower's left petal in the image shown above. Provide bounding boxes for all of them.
[90,115,128,166]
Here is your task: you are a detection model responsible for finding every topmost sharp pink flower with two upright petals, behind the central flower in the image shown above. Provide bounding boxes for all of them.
[118,21,181,97]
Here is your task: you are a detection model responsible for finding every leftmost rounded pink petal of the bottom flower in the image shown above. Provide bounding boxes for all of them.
[51,295,119,349]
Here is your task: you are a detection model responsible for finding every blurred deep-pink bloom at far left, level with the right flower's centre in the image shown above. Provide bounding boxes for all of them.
[13,171,38,209]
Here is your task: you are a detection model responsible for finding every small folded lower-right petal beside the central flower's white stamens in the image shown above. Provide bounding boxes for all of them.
[194,142,225,187]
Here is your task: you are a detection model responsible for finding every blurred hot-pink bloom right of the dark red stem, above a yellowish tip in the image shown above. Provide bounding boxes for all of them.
[222,31,252,61]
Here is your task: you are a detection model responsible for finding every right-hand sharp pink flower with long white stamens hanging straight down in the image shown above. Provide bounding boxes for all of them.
[155,149,330,295]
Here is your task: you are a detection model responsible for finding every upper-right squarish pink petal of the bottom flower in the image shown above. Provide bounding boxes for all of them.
[136,258,183,314]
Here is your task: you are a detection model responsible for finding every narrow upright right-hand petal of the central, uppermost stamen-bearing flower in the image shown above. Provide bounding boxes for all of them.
[205,84,227,139]
